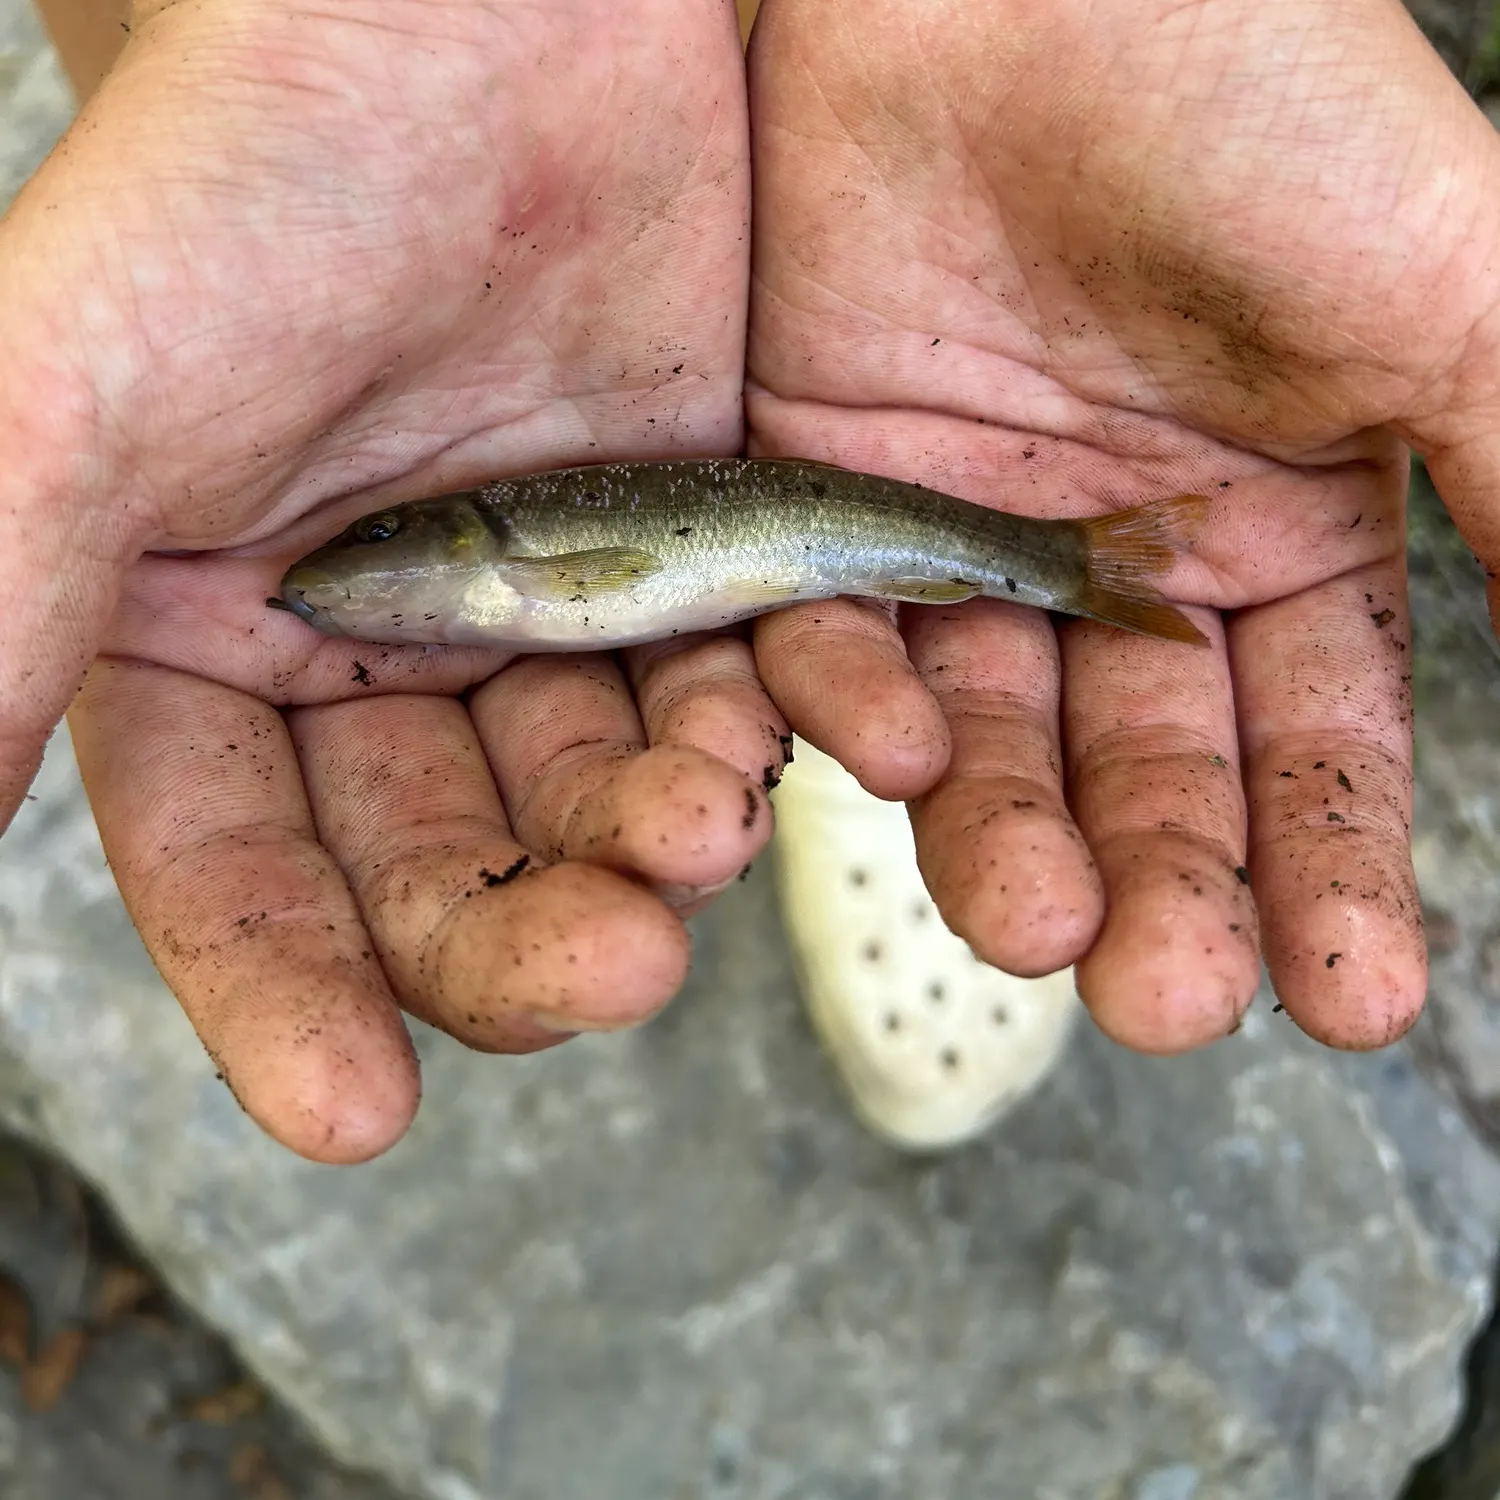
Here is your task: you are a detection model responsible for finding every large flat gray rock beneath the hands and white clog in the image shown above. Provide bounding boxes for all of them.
[0,720,1500,1500]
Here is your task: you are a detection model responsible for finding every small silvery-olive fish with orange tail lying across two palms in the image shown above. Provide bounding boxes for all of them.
[276,459,1209,653]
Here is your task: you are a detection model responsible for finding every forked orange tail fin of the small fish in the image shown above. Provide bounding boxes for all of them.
[1077,495,1211,645]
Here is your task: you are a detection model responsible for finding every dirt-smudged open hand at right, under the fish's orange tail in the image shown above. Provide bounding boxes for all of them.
[747,0,1500,1052]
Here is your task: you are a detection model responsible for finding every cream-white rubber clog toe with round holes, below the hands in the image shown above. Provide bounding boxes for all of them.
[774,740,1080,1152]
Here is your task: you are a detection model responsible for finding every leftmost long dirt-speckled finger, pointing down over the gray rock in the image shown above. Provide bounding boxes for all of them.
[69,660,420,1163]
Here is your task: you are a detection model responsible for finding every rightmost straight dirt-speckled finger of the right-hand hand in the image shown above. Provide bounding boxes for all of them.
[1229,555,1427,1049]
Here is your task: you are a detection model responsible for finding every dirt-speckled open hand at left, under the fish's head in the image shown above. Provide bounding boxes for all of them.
[0,0,785,1161]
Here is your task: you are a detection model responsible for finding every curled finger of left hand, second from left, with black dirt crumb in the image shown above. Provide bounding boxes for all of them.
[288,696,689,1052]
